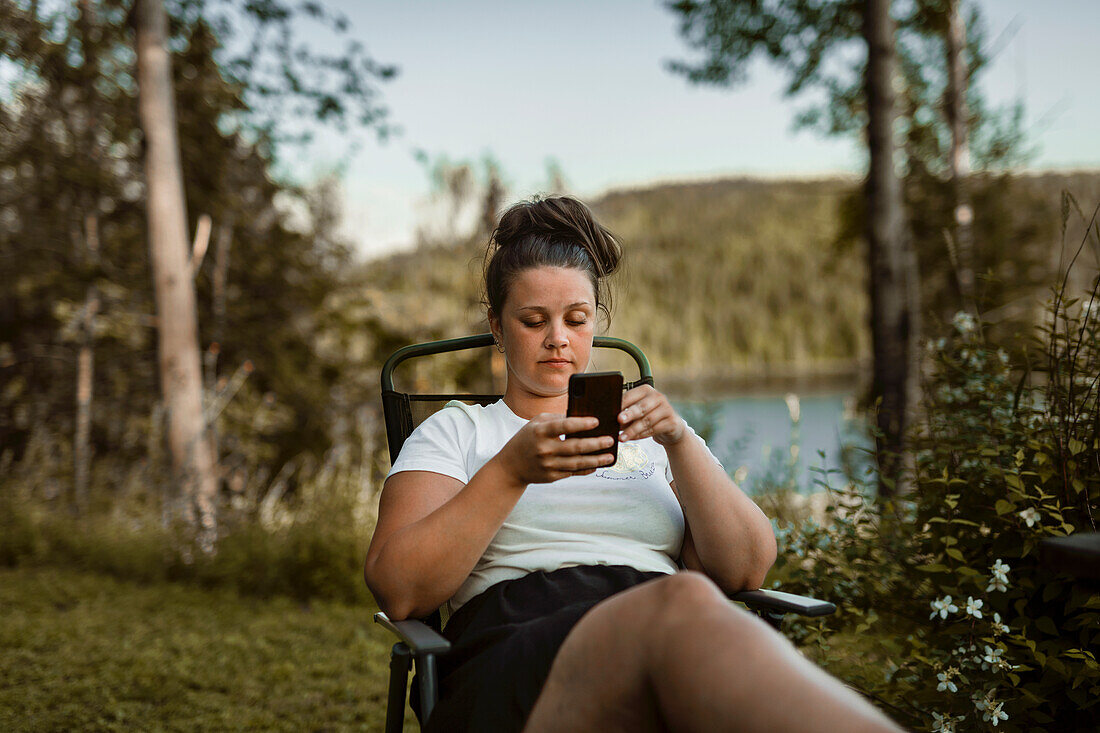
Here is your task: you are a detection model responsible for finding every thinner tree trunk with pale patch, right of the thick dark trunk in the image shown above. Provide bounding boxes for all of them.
[944,0,974,299]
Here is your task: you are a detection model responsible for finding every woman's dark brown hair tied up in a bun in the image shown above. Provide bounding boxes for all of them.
[482,196,623,320]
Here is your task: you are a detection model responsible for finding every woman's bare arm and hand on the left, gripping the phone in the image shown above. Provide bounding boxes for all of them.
[364,415,612,620]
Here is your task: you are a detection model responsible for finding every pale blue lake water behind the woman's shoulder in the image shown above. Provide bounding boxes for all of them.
[675,391,870,493]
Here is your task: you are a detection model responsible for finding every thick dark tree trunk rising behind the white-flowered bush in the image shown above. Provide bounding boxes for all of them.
[864,0,920,499]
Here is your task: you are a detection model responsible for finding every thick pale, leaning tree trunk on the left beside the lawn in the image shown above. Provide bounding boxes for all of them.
[134,0,217,541]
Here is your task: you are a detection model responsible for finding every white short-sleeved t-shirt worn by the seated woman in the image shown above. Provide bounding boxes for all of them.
[386,400,722,613]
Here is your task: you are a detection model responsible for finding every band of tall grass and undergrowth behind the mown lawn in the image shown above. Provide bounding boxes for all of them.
[0,444,373,602]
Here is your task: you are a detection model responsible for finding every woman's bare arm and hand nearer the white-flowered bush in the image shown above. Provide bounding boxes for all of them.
[619,386,777,592]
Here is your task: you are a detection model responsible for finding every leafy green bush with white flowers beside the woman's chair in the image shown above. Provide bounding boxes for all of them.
[774,278,1100,731]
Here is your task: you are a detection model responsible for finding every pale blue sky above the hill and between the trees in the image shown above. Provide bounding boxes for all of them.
[279,0,1100,258]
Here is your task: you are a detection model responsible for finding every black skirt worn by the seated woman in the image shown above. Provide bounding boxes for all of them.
[411,566,667,732]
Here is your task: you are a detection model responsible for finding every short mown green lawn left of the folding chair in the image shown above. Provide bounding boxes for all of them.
[0,568,416,731]
